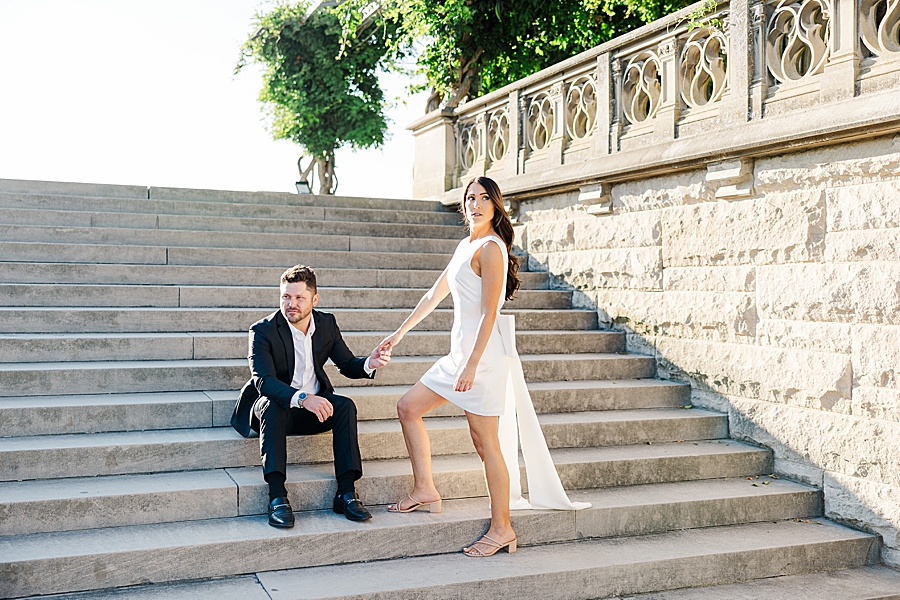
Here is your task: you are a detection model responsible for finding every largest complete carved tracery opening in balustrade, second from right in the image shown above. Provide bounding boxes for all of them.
[766,0,832,83]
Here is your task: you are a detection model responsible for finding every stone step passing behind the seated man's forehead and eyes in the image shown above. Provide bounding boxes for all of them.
[0,283,572,310]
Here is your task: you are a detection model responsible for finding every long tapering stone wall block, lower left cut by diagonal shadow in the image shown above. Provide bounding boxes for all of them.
[656,337,851,414]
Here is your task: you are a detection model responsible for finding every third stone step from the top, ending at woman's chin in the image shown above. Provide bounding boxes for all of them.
[0,208,465,240]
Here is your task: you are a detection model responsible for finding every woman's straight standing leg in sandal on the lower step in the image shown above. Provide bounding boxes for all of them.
[466,412,516,552]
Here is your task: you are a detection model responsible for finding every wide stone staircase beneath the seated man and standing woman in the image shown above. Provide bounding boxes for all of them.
[0,180,888,600]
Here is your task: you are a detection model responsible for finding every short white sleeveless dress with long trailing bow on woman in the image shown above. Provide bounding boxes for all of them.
[420,236,590,510]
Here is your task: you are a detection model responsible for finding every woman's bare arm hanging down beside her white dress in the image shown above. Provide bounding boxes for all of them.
[453,243,506,392]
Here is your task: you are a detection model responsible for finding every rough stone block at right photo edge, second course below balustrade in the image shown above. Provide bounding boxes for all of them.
[825,180,900,232]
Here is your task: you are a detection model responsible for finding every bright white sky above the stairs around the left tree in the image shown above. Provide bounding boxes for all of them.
[0,0,426,198]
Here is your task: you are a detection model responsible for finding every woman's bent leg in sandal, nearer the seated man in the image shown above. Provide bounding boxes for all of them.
[397,382,447,510]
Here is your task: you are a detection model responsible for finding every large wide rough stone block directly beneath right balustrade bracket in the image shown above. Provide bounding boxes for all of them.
[662,191,825,267]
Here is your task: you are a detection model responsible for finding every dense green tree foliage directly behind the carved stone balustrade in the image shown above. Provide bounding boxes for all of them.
[333,0,690,107]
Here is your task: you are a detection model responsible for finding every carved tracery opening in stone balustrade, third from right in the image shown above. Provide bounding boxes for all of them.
[678,29,728,108]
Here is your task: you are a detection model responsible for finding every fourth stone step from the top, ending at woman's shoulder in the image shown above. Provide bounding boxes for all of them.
[0,224,463,254]
